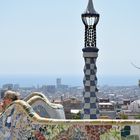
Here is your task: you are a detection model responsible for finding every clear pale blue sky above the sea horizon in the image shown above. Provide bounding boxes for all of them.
[0,0,140,85]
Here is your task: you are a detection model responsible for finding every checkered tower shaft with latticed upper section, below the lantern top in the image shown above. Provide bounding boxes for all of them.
[82,25,99,119]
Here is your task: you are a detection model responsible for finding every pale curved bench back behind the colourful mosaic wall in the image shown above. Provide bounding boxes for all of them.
[25,92,65,119]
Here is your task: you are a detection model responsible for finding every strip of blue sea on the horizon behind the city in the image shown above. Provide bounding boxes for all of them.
[0,75,140,87]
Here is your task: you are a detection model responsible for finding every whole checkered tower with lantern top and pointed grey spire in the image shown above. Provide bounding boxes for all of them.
[81,0,99,119]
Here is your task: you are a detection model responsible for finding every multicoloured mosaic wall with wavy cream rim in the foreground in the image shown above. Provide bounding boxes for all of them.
[0,101,140,140]
